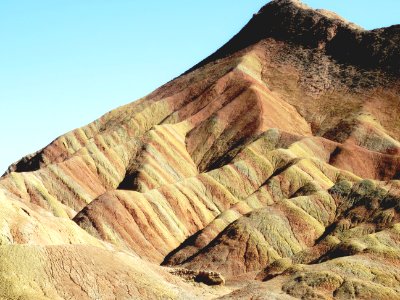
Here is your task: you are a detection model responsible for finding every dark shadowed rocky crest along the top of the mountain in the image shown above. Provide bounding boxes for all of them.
[189,0,400,74]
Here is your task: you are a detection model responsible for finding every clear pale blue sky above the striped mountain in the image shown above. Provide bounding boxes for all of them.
[0,0,400,174]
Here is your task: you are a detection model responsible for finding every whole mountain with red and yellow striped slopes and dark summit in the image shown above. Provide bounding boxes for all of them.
[0,0,400,299]
